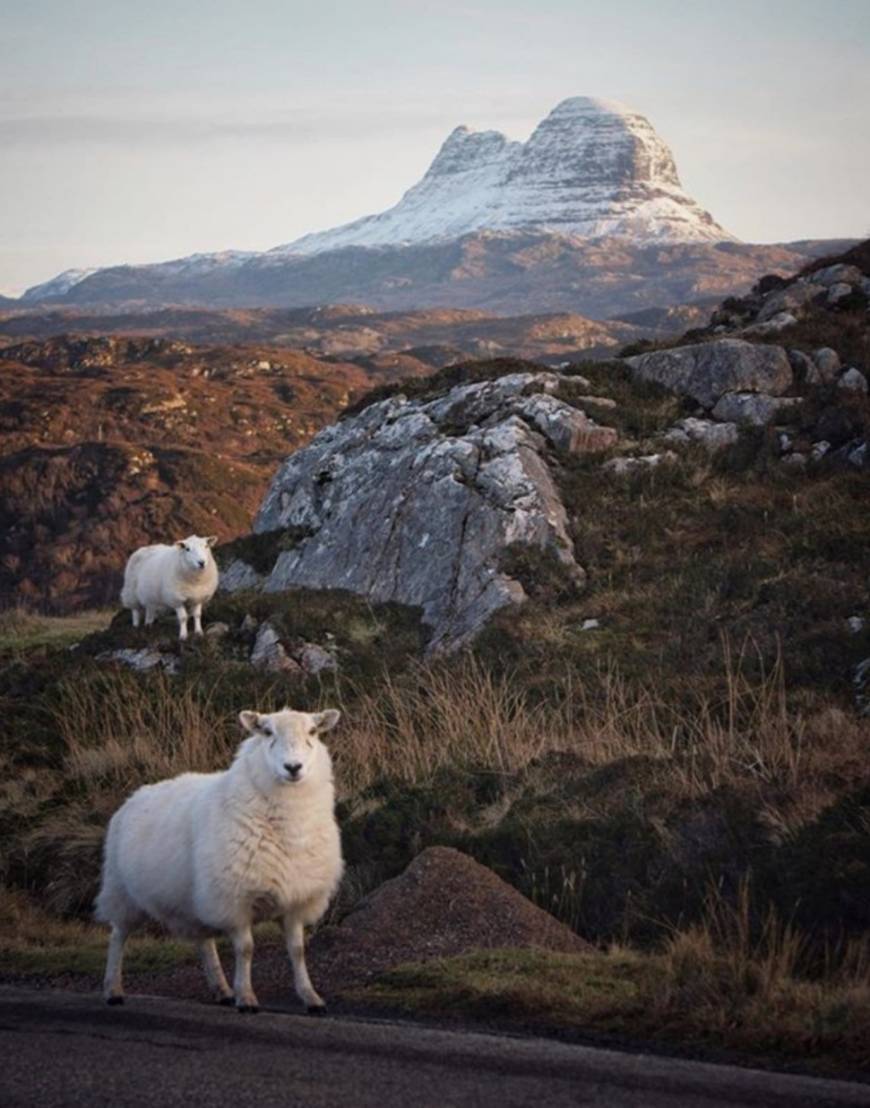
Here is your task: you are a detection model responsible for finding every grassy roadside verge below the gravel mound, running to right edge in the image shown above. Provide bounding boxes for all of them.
[350,937,870,1075]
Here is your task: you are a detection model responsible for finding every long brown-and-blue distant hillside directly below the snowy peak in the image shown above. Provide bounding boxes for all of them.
[8,230,848,319]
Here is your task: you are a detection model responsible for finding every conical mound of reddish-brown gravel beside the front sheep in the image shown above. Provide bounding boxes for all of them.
[310,847,590,981]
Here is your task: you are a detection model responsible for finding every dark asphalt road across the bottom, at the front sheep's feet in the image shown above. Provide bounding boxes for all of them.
[0,987,870,1108]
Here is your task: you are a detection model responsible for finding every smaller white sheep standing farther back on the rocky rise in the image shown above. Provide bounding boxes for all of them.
[121,535,217,642]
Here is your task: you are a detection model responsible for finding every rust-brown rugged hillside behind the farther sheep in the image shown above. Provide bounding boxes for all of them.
[0,336,416,609]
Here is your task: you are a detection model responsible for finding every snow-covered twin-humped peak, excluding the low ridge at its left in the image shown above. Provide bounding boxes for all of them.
[280,96,734,254]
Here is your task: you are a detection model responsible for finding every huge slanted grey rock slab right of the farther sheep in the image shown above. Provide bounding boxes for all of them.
[248,373,602,650]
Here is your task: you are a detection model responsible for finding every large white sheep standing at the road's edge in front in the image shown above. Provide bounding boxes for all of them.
[95,708,344,1013]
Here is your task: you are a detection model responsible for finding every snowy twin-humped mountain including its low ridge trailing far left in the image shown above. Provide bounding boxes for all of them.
[22,96,734,304]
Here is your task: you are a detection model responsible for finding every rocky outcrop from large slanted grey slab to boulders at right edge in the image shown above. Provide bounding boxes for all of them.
[224,244,870,652]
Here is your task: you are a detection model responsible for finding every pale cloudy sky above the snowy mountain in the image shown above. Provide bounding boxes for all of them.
[0,0,870,295]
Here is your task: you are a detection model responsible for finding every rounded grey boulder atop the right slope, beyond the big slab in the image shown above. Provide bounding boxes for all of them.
[626,339,792,408]
